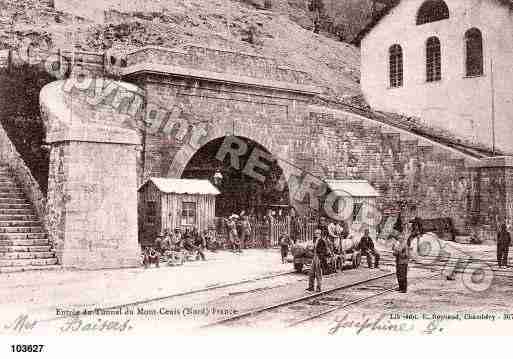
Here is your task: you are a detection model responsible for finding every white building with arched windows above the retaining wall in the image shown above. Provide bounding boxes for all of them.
[357,0,513,153]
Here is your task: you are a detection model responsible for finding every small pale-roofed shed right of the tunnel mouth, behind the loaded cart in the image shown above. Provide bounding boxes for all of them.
[325,180,380,235]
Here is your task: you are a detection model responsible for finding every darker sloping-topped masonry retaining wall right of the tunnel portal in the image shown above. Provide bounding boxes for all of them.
[311,113,471,231]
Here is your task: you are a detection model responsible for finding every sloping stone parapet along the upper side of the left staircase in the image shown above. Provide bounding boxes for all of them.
[0,124,47,231]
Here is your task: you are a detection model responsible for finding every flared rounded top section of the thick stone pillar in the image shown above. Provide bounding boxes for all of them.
[39,78,144,145]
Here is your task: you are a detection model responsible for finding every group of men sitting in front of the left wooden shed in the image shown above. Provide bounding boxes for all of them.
[143,227,218,267]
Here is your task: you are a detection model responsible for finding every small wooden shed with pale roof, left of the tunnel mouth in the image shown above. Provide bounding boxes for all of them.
[138,177,220,245]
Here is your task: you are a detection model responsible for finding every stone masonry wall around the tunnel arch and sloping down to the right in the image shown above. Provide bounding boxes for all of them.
[139,77,473,232]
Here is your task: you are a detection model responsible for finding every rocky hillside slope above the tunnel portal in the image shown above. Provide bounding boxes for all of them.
[0,0,359,99]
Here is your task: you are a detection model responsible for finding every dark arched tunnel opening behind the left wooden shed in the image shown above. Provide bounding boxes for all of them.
[181,136,290,217]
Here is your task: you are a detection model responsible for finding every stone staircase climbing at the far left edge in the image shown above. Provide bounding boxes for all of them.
[0,164,59,273]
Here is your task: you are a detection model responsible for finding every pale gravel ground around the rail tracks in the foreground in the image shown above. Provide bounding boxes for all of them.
[0,244,513,335]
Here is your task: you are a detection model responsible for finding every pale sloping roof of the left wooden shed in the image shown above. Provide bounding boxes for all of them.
[139,177,221,196]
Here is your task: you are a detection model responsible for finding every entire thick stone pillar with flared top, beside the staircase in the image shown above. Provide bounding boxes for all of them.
[40,82,140,269]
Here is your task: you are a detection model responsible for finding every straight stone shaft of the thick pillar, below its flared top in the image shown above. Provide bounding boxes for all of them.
[48,142,140,269]
